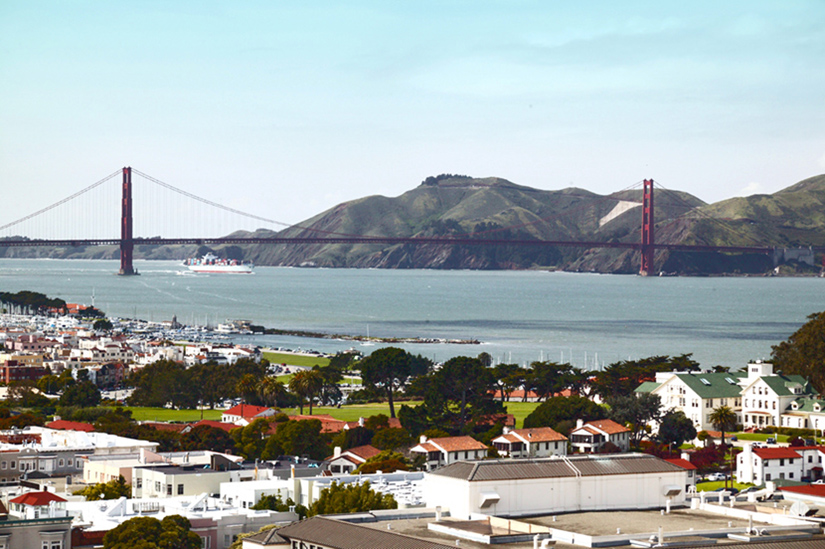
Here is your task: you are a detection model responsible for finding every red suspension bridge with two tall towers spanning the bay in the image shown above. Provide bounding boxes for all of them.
[0,167,825,276]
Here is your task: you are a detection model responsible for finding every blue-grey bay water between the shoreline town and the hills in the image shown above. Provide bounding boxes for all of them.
[0,259,825,368]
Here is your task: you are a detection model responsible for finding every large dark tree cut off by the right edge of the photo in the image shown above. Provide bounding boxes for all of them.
[771,312,825,393]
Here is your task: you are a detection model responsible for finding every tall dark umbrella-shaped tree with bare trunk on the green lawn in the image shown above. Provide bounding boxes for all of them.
[358,347,431,418]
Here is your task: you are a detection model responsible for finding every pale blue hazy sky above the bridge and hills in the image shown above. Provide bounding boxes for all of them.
[0,0,825,231]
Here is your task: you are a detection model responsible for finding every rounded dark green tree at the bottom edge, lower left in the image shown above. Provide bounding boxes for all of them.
[103,515,201,549]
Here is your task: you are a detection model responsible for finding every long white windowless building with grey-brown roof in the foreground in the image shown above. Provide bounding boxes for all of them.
[424,454,687,519]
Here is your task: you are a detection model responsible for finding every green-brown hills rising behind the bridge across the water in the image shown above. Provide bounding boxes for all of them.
[0,175,825,274]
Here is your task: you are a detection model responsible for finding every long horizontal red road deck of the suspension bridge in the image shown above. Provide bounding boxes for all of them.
[0,236,804,254]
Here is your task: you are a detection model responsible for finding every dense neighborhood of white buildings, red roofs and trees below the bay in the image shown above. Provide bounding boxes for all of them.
[0,298,825,549]
